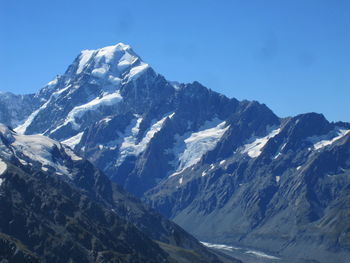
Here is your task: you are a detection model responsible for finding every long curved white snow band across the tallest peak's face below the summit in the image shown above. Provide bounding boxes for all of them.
[62,91,123,130]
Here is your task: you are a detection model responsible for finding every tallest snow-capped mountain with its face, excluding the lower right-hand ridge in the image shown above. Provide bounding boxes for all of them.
[16,44,238,196]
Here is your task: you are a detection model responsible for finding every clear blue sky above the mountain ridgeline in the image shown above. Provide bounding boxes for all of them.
[0,0,350,121]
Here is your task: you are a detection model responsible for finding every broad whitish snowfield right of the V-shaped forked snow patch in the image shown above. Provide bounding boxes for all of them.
[170,119,229,176]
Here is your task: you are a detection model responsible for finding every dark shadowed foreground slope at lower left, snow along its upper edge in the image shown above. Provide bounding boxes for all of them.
[0,125,235,262]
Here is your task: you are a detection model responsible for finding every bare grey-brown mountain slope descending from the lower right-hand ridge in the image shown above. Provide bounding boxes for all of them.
[145,114,350,262]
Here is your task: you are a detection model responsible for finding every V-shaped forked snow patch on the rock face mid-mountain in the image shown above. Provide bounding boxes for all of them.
[117,113,173,166]
